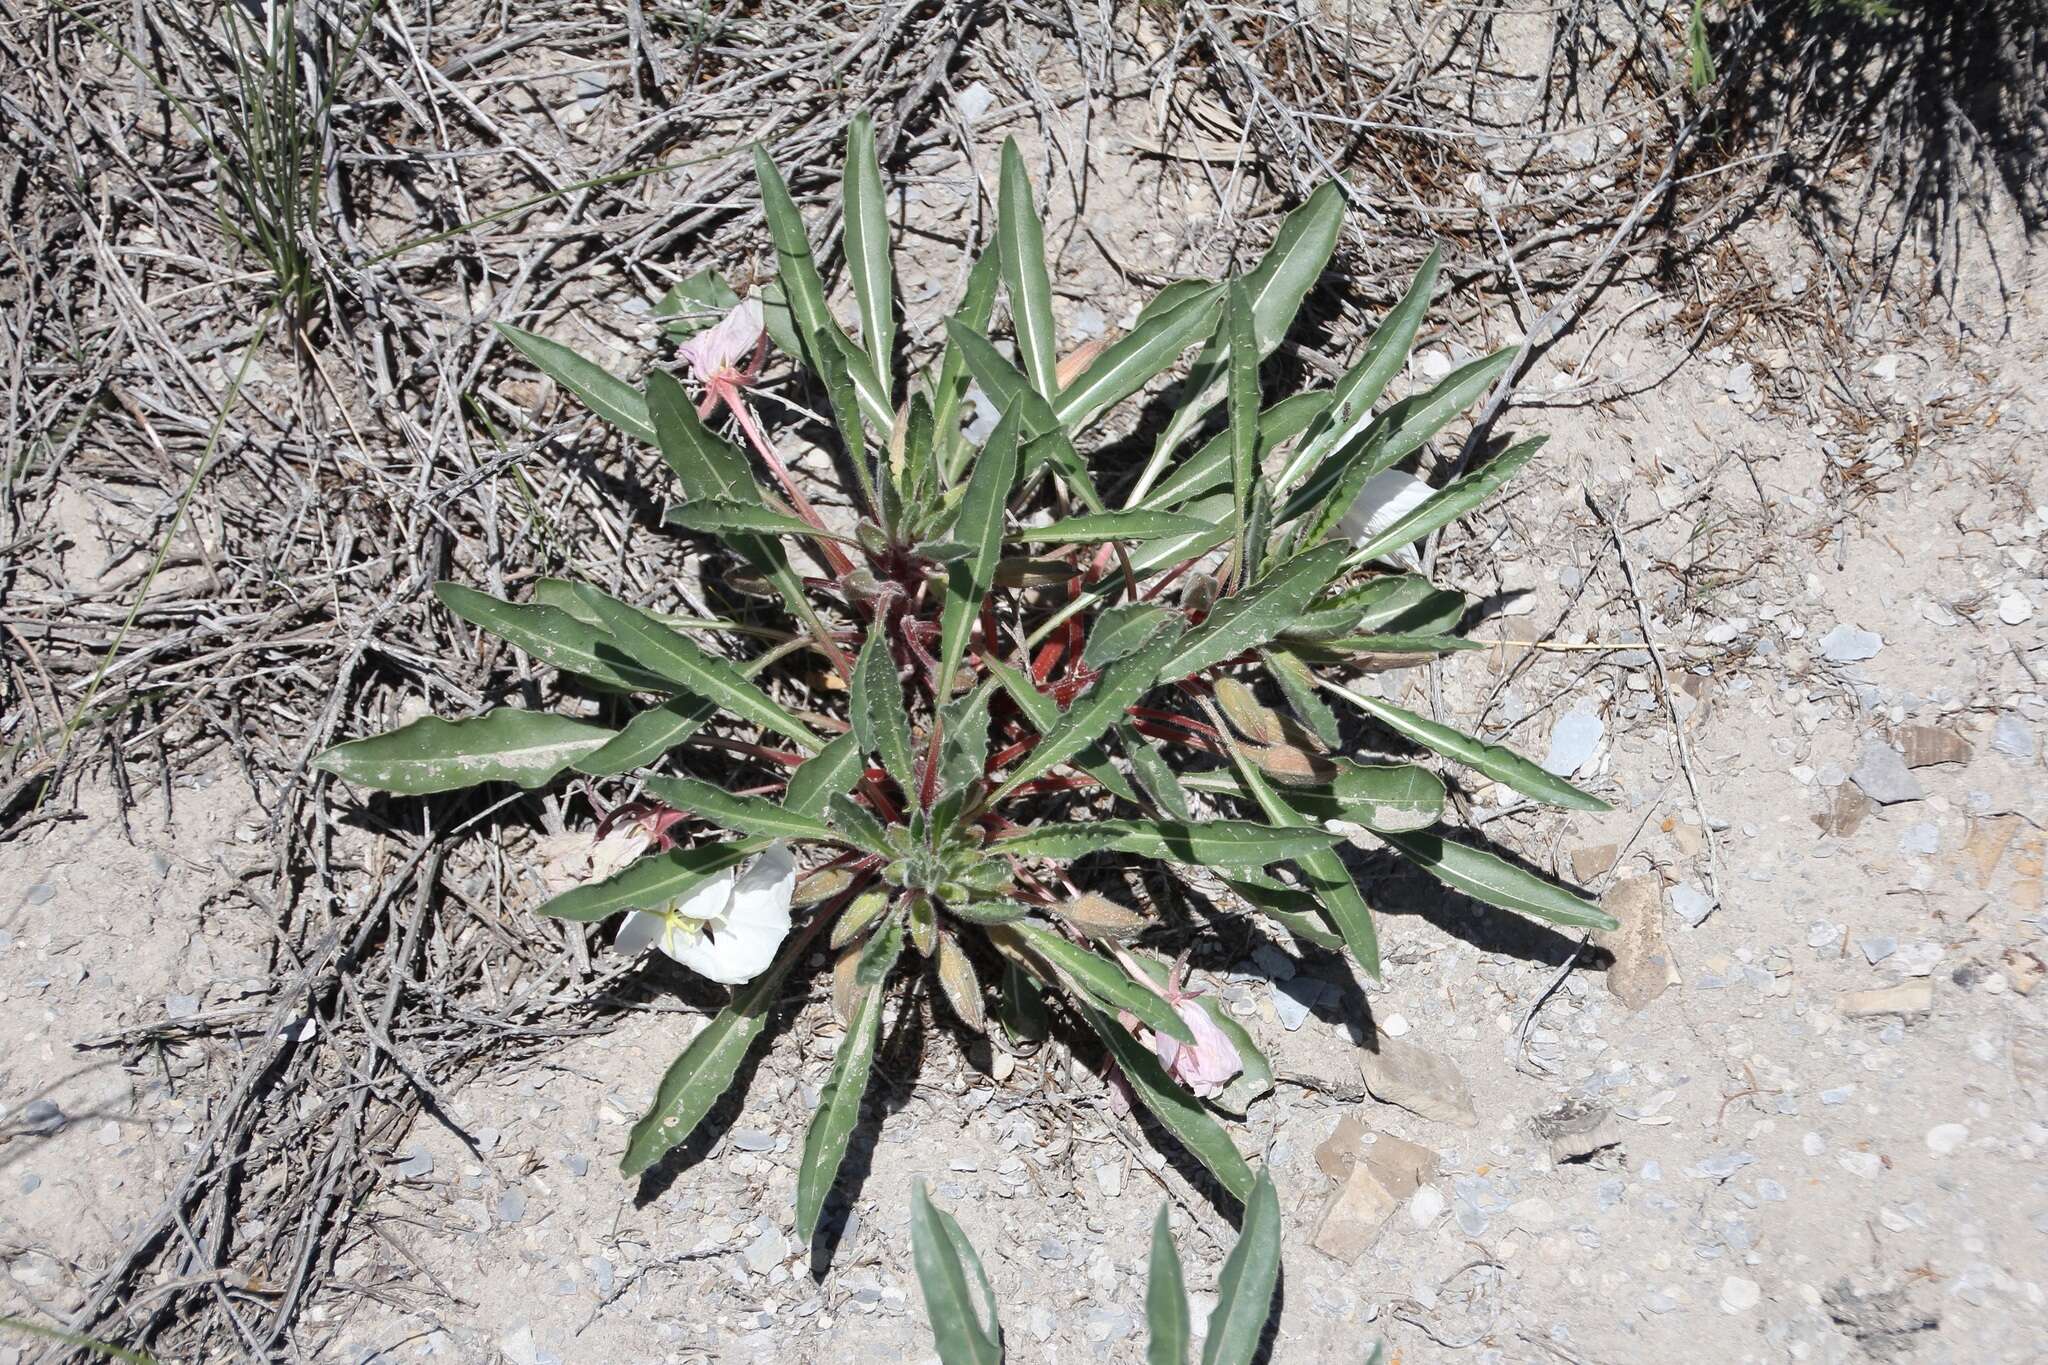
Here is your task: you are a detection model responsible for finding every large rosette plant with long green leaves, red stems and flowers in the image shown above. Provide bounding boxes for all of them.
[319,119,1612,1236]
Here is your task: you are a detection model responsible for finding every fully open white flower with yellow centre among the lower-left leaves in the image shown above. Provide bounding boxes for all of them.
[612,839,797,986]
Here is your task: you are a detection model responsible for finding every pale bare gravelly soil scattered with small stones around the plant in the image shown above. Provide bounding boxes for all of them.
[0,2,2048,1365]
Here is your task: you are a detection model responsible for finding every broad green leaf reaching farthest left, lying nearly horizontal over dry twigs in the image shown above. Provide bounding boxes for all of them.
[313,706,612,796]
